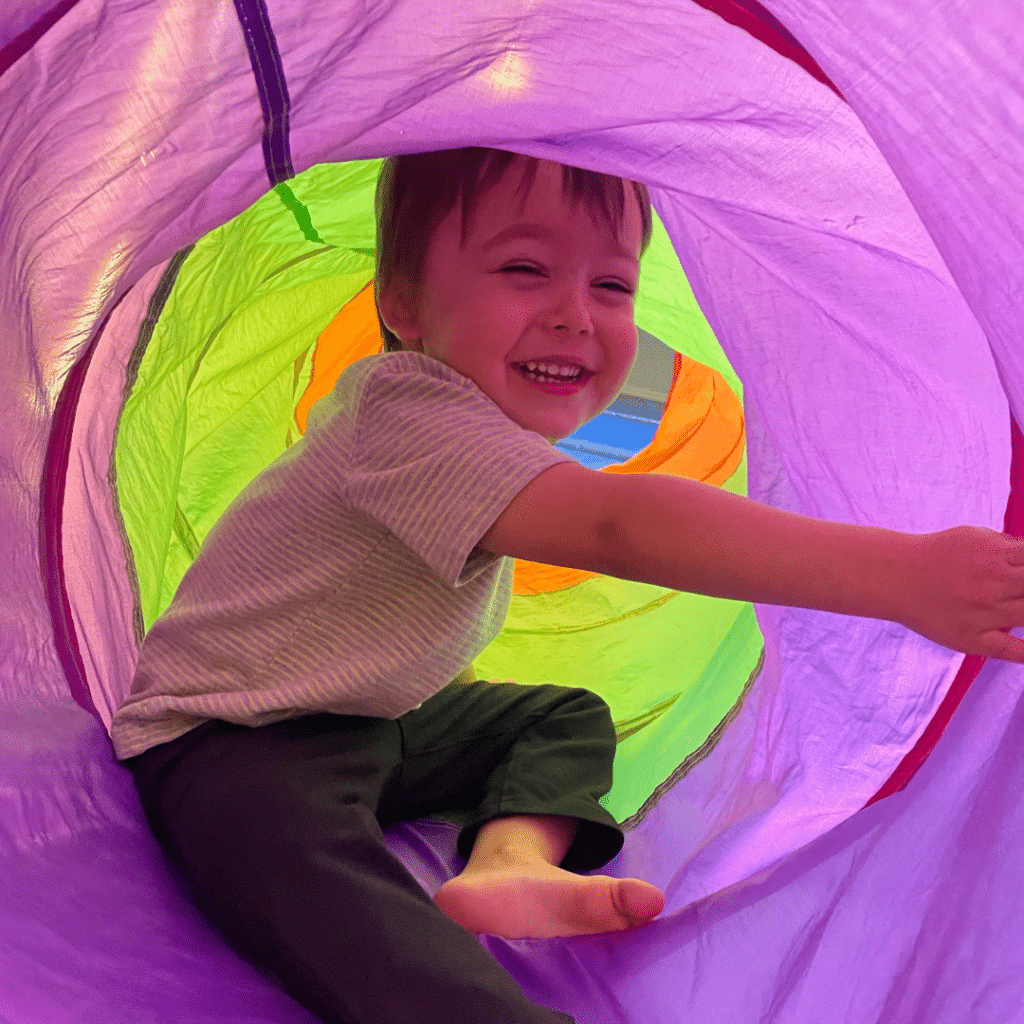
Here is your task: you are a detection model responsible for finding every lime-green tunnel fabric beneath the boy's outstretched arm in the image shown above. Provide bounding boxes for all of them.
[473,458,763,821]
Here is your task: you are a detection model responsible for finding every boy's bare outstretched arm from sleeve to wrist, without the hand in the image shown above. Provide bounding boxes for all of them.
[479,463,916,618]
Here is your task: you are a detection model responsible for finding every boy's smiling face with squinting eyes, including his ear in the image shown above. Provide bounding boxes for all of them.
[379,159,642,441]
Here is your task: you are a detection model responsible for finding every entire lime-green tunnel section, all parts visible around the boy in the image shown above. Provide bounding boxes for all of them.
[115,160,763,820]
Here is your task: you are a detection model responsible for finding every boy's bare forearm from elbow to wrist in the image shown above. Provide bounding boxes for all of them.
[609,474,915,621]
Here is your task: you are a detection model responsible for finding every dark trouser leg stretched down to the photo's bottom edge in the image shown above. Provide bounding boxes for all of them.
[125,715,572,1024]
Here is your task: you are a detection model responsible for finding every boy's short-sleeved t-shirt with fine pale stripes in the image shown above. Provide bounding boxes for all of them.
[111,352,572,760]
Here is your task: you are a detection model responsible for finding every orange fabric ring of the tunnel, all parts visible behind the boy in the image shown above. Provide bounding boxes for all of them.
[295,282,745,594]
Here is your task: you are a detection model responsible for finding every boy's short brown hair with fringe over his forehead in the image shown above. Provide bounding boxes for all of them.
[374,146,652,352]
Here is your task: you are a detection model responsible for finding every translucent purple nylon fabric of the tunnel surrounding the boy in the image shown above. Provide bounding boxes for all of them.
[0,0,1024,1024]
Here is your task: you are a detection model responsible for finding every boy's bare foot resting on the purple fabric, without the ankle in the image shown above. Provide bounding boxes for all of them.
[434,853,665,939]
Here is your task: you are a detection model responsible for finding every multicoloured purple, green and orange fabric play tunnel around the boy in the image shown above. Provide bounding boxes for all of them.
[6,0,1024,1024]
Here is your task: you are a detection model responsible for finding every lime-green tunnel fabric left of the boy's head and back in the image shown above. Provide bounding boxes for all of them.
[116,160,380,629]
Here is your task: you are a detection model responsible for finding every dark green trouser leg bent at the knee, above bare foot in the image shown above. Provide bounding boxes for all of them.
[378,681,624,872]
